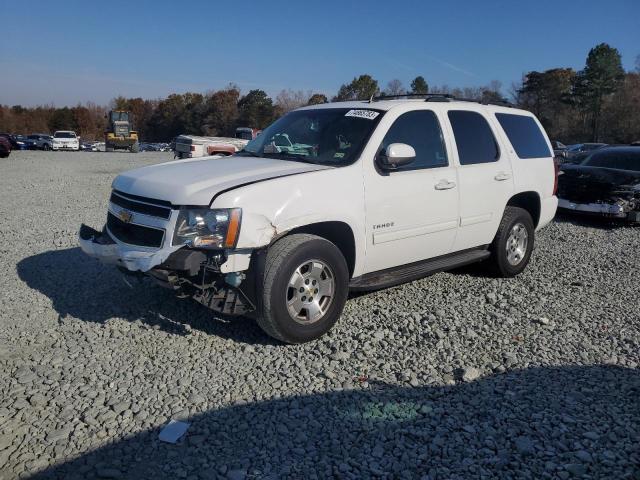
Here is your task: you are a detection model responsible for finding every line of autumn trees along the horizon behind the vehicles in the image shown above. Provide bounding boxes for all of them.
[0,43,640,143]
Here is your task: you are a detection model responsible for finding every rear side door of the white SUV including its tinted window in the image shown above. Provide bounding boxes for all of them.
[447,109,513,251]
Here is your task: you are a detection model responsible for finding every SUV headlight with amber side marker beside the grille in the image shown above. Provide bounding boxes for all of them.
[172,208,242,248]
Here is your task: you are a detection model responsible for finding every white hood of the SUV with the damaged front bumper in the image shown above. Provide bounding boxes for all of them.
[111,157,332,205]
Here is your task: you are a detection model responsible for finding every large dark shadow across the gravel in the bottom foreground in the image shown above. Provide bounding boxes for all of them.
[25,366,640,480]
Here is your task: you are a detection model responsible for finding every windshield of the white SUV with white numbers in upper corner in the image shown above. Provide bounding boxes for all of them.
[238,108,382,166]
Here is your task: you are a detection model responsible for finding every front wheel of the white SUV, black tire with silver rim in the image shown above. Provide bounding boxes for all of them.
[257,234,349,343]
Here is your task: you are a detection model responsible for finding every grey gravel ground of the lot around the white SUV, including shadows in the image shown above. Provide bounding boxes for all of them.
[0,152,640,479]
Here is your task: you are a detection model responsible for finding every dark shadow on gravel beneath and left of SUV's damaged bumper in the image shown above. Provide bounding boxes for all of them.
[17,248,275,344]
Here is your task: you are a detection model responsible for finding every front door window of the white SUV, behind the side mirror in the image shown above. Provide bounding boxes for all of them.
[380,110,448,171]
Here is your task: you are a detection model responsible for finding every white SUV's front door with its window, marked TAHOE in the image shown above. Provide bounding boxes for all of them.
[365,109,458,273]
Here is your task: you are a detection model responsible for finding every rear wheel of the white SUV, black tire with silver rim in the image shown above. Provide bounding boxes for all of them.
[489,206,535,278]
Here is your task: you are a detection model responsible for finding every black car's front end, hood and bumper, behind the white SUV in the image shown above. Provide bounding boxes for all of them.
[558,165,640,222]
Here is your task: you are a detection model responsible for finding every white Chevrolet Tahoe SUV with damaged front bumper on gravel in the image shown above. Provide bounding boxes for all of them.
[79,95,557,343]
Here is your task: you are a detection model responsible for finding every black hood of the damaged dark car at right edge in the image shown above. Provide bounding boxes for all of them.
[558,165,640,202]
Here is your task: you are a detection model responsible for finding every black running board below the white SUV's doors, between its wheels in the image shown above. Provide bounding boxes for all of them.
[349,248,491,291]
